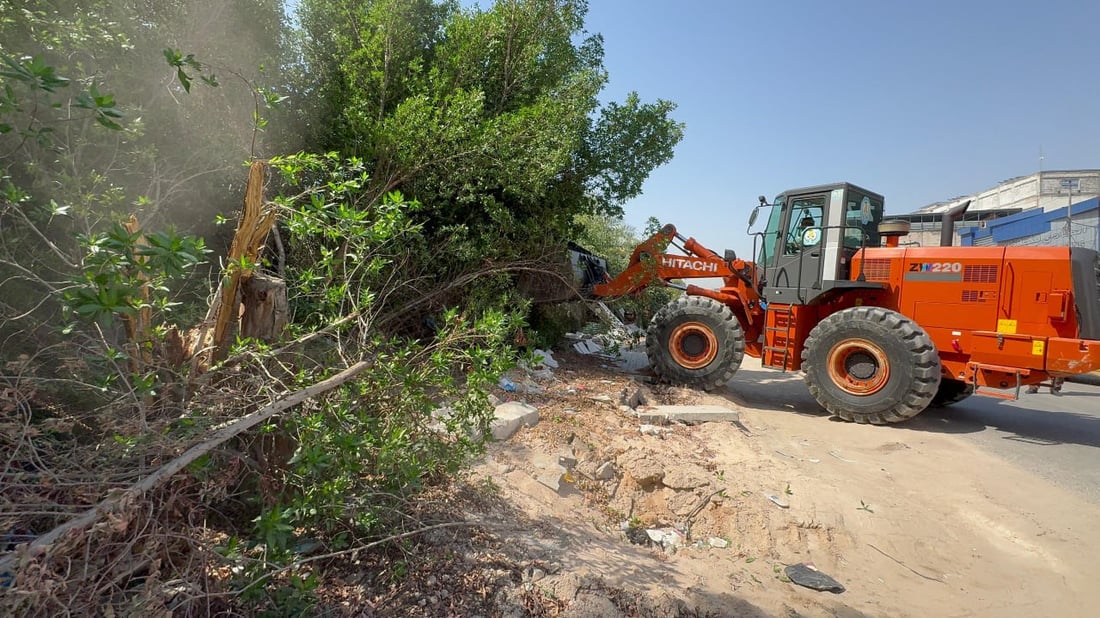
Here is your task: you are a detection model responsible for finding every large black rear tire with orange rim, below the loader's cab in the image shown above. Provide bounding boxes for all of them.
[802,307,941,424]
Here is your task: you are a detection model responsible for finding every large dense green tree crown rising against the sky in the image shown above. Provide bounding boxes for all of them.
[300,0,682,294]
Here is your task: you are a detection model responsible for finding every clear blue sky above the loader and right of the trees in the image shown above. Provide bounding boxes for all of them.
[580,0,1100,255]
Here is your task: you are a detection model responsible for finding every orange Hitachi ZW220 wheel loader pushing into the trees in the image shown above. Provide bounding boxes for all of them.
[572,183,1100,424]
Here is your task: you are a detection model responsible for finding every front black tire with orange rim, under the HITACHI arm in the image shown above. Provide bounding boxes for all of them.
[646,296,745,390]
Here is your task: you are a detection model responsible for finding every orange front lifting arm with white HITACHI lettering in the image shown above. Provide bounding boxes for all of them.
[592,224,763,342]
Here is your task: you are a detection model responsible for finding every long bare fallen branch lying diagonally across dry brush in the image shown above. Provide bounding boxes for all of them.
[0,361,373,573]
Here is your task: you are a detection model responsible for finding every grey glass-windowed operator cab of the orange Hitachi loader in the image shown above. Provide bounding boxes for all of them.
[750,183,884,305]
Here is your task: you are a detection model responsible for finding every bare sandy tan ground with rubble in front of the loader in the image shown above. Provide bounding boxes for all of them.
[474,354,1100,617]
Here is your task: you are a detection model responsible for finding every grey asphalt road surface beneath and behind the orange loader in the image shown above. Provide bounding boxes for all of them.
[729,357,1100,504]
